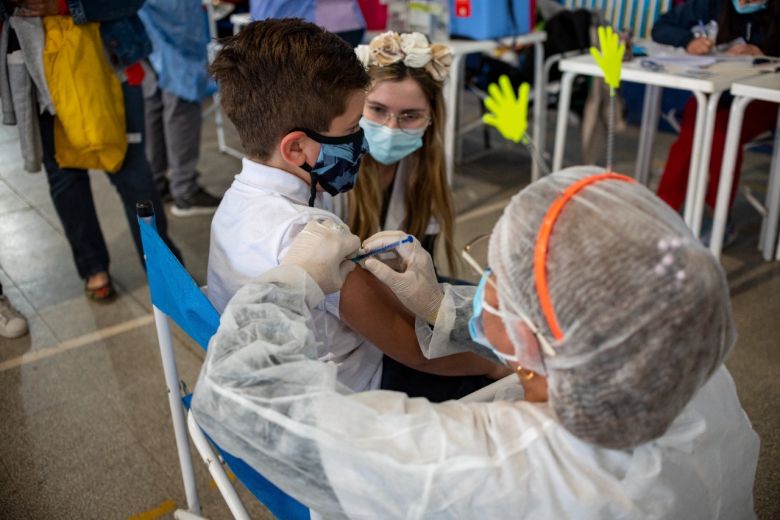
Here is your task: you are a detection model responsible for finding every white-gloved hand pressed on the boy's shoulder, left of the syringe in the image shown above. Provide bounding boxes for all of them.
[281,220,360,294]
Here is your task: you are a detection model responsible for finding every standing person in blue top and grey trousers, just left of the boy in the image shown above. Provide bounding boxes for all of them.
[138,0,220,217]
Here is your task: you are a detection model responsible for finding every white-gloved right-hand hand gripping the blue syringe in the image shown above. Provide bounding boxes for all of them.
[363,231,444,324]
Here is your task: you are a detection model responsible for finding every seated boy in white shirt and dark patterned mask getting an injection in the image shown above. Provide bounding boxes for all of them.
[208,19,504,395]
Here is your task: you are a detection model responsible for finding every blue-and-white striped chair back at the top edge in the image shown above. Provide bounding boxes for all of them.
[563,0,672,38]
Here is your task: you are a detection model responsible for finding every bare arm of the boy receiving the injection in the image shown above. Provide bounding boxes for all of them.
[339,267,509,379]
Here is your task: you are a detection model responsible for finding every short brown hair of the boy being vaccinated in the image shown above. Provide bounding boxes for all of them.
[211,18,370,160]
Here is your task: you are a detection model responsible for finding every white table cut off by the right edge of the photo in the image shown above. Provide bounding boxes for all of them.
[710,73,780,260]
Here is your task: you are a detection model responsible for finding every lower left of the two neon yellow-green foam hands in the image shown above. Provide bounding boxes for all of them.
[482,76,529,143]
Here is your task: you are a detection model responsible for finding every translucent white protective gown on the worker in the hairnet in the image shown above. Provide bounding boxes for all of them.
[192,266,759,520]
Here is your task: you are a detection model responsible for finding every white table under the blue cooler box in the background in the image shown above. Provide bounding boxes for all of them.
[442,31,547,184]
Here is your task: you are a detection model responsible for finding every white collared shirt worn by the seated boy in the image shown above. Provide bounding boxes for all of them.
[208,159,383,392]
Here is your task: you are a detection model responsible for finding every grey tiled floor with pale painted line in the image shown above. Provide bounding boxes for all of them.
[0,96,780,519]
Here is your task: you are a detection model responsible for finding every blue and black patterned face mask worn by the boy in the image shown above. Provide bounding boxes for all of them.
[298,128,368,206]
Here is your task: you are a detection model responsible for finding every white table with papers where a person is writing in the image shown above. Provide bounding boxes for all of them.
[553,55,761,236]
